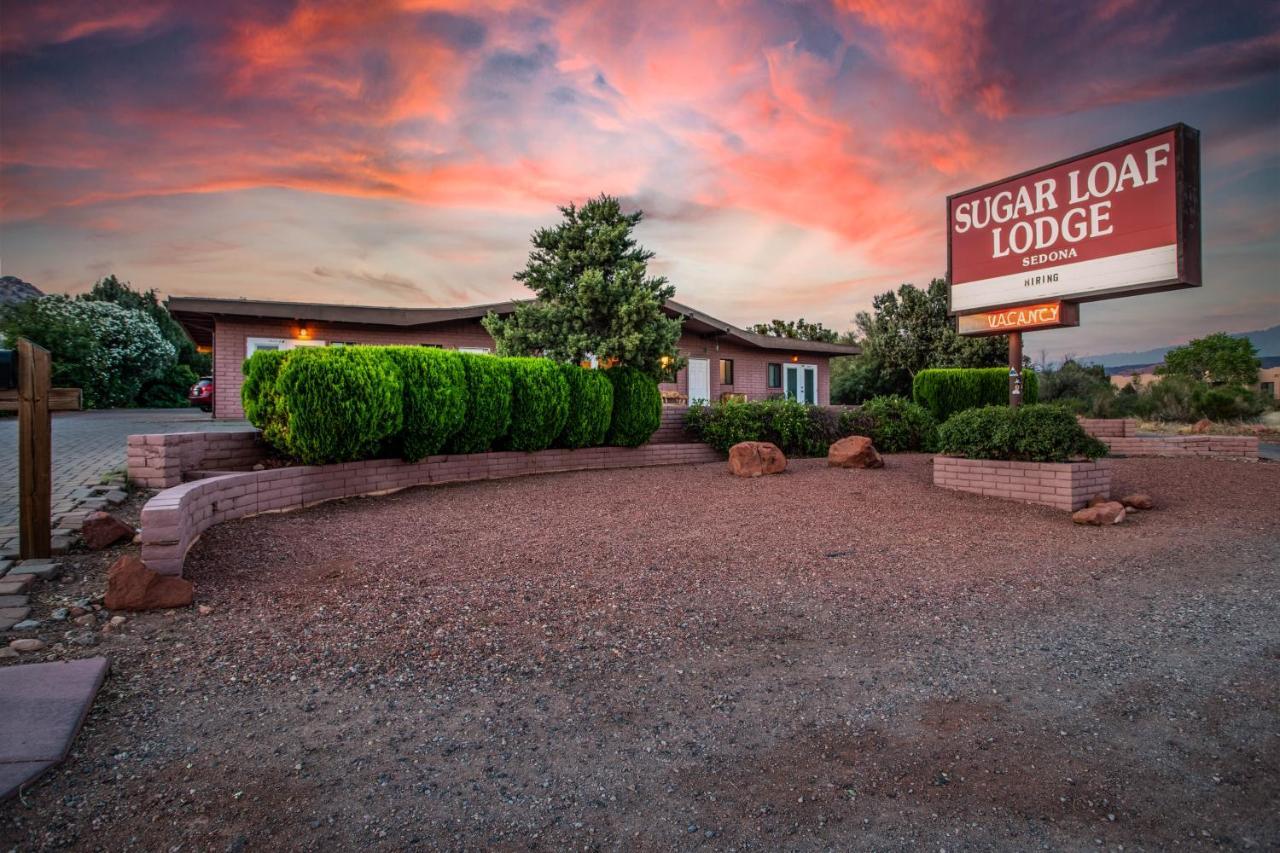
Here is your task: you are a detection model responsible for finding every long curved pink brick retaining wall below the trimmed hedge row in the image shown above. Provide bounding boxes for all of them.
[142,435,721,575]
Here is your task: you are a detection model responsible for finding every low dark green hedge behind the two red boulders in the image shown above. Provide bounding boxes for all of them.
[685,397,937,456]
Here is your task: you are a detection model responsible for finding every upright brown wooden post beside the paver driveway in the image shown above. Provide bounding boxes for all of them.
[18,338,54,560]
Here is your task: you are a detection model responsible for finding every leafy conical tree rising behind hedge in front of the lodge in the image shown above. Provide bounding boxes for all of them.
[484,195,682,378]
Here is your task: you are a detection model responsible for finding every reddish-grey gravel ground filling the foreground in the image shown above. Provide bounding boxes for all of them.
[0,456,1280,850]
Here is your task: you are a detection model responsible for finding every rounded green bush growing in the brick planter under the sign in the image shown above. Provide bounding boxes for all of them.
[938,405,1107,462]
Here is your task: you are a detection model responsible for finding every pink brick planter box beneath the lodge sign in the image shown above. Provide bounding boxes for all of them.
[933,456,1111,511]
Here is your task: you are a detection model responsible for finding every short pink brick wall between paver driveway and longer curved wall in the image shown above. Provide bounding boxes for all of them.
[125,429,266,489]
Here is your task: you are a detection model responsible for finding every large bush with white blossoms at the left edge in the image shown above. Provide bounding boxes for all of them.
[3,295,177,409]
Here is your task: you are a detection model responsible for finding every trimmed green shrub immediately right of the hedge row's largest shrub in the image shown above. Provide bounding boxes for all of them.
[379,347,467,462]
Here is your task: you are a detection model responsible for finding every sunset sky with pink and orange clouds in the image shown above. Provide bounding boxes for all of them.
[0,0,1280,357]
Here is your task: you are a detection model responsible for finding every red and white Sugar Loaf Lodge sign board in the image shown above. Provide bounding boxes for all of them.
[947,124,1201,313]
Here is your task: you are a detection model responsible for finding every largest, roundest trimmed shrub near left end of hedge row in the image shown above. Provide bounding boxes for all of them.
[275,347,404,465]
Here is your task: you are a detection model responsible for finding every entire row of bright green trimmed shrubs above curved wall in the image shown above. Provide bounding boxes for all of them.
[241,346,662,464]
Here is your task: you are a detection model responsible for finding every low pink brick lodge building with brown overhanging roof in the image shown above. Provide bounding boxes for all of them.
[168,296,859,418]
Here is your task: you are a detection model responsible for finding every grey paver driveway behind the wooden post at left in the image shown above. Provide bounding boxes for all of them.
[0,409,248,551]
